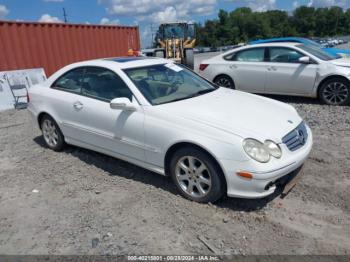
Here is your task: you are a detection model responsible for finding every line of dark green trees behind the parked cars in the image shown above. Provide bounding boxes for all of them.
[196,6,350,47]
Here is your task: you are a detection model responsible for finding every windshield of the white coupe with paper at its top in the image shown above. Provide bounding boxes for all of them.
[124,63,216,105]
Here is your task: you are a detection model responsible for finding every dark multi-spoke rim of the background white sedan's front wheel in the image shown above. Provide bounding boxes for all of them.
[322,82,349,105]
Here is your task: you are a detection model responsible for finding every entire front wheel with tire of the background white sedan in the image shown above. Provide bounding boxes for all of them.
[318,78,350,106]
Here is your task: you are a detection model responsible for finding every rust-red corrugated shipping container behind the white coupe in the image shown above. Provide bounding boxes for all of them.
[0,21,140,76]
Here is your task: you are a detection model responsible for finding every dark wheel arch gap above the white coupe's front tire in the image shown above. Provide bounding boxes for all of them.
[164,141,227,191]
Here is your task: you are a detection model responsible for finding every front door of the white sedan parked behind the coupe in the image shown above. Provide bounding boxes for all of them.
[265,47,317,95]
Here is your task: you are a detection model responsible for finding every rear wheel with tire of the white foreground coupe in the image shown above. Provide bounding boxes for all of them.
[40,115,65,151]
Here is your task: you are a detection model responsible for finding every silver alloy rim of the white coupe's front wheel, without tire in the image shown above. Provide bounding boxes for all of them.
[175,156,212,198]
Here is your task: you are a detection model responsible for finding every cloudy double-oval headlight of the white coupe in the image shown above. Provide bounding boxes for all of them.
[243,138,282,163]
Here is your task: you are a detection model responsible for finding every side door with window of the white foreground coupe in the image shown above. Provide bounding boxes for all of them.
[52,67,145,161]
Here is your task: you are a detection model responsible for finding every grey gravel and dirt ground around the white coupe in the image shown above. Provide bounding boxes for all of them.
[0,97,350,255]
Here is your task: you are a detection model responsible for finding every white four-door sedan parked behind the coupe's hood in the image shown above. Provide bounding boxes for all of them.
[199,43,350,105]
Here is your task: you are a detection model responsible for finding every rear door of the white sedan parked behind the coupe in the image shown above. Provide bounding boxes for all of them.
[224,47,266,93]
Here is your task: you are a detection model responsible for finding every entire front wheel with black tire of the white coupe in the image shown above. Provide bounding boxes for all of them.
[170,147,225,203]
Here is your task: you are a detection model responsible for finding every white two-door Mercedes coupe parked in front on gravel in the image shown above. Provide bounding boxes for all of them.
[28,57,312,202]
